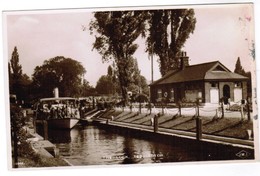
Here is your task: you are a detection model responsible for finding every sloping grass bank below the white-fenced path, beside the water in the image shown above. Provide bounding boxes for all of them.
[96,110,253,139]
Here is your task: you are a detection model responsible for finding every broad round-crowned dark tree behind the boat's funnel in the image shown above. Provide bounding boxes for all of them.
[33,56,86,97]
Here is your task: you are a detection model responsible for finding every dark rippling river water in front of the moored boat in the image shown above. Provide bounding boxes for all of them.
[43,125,253,166]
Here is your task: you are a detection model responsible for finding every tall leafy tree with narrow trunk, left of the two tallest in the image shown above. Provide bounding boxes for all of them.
[90,11,147,104]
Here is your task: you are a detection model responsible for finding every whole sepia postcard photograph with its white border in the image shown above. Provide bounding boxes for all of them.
[3,2,259,171]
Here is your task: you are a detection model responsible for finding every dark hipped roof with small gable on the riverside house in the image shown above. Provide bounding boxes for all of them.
[150,61,248,85]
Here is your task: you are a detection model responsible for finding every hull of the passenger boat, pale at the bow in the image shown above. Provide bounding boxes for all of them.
[48,118,79,129]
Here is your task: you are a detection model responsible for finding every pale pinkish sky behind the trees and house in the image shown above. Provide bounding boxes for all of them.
[4,4,254,86]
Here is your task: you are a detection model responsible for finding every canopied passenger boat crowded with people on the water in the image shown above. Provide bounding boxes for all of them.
[35,97,80,129]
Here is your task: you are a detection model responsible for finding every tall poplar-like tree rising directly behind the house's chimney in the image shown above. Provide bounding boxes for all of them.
[146,9,196,76]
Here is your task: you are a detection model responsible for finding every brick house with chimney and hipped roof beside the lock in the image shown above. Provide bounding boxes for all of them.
[150,52,248,105]
